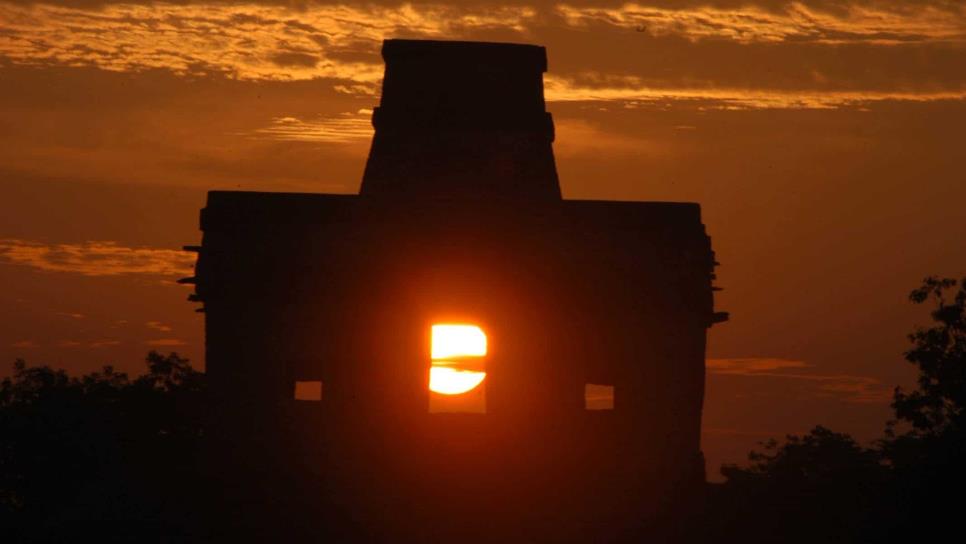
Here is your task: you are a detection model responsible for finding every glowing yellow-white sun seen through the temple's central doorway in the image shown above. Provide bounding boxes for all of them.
[429,325,486,395]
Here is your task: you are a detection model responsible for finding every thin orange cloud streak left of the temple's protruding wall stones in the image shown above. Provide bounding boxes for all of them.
[0,239,195,276]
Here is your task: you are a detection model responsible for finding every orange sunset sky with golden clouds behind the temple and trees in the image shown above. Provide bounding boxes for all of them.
[0,0,966,474]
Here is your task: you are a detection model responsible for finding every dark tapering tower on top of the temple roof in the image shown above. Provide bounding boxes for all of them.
[360,40,560,202]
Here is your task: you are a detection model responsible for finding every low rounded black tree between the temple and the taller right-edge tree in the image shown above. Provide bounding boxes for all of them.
[706,426,888,542]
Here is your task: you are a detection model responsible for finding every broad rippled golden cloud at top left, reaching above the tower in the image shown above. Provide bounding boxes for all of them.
[0,2,536,83]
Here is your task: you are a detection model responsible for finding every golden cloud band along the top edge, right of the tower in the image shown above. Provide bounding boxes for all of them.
[556,2,966,45]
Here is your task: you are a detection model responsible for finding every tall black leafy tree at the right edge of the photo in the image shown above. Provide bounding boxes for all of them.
[879,277,966,541]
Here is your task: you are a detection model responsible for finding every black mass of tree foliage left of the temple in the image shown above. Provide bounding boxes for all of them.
[0,351,205,541]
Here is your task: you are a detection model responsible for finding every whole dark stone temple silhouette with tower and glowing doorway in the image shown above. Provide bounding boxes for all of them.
[183,40,727,542]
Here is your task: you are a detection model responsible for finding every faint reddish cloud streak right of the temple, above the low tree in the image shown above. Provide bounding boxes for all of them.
[707,357,892,403]
